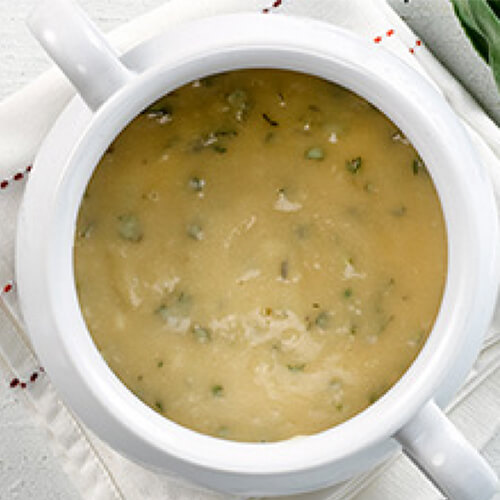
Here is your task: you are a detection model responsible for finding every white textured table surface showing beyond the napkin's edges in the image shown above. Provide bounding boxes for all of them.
[0,0,500,500]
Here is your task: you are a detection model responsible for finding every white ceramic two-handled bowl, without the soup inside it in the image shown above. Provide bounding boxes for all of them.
[17,0,499,500]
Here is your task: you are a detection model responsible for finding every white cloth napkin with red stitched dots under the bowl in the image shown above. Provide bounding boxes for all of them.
[0,0,500,500]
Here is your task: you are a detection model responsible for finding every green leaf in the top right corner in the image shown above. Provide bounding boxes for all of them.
[451,0,500,89]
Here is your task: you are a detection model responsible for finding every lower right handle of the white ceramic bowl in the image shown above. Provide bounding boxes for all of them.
[395,401,500,500]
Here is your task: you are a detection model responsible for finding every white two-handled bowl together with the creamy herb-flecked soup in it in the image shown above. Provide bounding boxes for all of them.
[16,4,498,500]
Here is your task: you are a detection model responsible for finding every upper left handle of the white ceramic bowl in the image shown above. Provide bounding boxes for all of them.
[27,0,134,110]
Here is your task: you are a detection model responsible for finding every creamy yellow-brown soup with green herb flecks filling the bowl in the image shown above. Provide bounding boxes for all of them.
[74,70,446,441]
